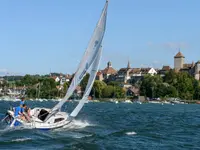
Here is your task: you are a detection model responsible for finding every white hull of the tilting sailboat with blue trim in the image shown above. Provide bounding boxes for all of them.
[8,108,72,130]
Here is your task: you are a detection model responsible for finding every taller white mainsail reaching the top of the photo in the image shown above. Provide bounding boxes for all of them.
[46,0,108,116]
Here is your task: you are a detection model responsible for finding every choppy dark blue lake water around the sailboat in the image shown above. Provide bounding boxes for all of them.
[0,101,200,150]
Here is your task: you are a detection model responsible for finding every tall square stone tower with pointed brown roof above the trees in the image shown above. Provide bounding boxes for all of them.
[174,51,185,71]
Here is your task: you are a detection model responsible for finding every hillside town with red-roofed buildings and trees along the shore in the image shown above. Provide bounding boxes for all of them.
[0,51,200,102]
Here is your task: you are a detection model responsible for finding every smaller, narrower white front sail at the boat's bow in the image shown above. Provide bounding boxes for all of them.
[70,47,102,117]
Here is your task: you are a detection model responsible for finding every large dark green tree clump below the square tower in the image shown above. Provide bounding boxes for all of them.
[140,70,200,100]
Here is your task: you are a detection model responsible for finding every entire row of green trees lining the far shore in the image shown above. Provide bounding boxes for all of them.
[0,70,200,100]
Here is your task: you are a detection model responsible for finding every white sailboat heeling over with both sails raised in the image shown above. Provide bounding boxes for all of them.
[5,0,108,130]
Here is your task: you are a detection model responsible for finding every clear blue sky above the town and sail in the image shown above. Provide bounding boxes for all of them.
[0,0,200,75]
